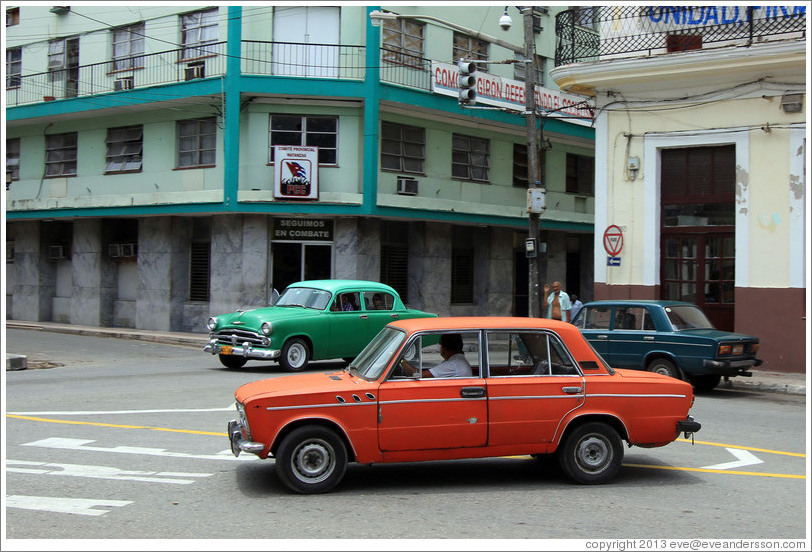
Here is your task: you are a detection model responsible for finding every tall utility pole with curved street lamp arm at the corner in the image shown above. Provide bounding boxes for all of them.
[369,6,546,317]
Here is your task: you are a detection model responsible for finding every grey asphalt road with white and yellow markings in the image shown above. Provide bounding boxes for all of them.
[4,329,809,550]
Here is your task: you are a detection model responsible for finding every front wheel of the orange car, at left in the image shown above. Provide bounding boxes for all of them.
[276,425,347,494]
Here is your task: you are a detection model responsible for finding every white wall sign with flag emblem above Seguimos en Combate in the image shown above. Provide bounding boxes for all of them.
[273,146,319,199]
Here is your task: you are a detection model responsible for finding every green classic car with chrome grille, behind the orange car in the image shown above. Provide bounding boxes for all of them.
[203,280,437,372]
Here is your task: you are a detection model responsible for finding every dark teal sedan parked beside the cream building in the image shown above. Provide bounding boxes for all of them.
[572,300,762,391]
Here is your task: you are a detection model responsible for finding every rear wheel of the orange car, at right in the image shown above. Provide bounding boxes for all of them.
[558,422,623,485]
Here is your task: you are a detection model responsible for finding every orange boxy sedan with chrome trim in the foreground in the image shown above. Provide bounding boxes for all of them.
[228,317,700,494]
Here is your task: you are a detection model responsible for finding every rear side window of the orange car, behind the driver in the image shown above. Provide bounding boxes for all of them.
[488,332,578,377]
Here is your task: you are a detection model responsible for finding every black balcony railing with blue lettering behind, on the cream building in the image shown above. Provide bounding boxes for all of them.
[555,6,806,66]
